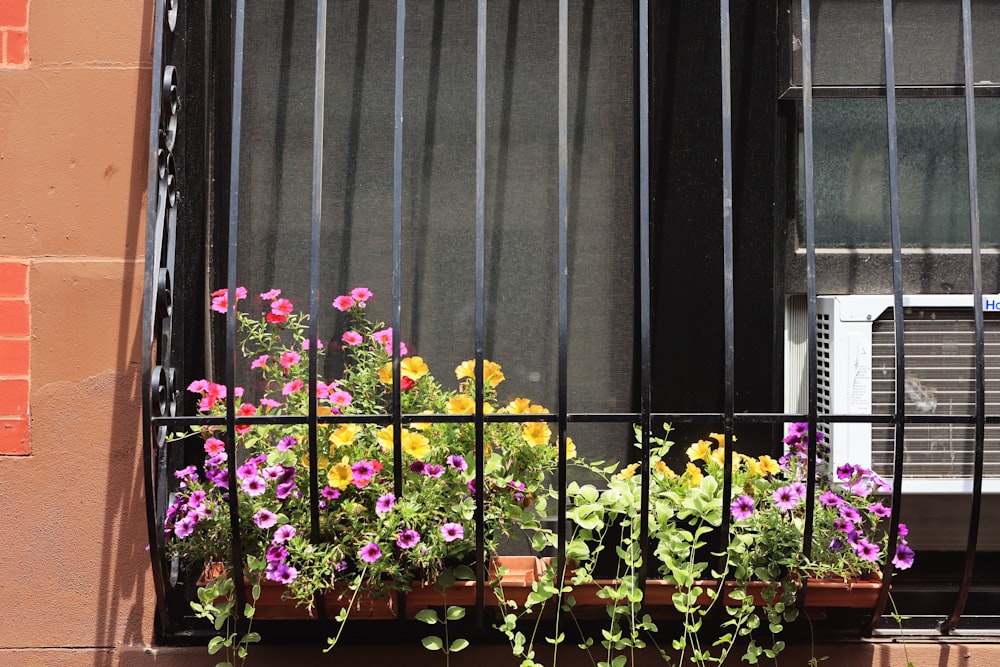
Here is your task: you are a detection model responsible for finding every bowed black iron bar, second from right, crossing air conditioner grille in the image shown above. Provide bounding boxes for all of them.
[869,0,906,634]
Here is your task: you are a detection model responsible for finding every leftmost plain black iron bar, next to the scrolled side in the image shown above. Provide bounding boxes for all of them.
[225,0,246,611]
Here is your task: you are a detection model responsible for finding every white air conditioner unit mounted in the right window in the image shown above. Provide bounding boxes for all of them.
[785,295,1000,493]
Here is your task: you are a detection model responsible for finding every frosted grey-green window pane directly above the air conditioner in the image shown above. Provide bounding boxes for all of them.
[798,98,1000,248]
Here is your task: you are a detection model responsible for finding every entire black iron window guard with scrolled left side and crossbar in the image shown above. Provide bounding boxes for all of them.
[143,0,1000,648]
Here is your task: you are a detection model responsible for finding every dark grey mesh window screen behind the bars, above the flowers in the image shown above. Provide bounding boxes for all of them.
[232,0,634,457]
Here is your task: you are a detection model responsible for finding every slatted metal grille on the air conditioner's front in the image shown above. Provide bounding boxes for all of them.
[872,308,1000,479]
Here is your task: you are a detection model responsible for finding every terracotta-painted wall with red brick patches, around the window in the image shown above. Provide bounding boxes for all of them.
[0,0,1000,667]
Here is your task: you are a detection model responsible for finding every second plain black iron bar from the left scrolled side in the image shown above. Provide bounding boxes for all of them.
[309,0,326,542]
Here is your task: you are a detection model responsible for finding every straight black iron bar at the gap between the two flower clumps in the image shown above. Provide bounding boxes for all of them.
[556,0,569,589]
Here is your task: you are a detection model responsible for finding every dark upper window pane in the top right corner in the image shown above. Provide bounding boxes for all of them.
[788,0,1000,86]
